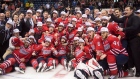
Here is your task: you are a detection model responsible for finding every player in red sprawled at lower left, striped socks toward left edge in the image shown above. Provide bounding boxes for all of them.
[0,37,33,74]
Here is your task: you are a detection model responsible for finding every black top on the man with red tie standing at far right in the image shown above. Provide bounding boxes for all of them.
[111,14,140,39]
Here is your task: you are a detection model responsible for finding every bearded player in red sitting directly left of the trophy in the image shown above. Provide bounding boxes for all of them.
[55,36,68,70]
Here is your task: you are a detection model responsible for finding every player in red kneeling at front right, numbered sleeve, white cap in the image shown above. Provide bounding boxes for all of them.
[99,27,133,79]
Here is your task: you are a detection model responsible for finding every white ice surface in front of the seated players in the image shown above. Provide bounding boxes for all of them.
[0,65,140,79]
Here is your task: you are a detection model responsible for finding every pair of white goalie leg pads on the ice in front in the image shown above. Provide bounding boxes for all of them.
[74,58,104,79]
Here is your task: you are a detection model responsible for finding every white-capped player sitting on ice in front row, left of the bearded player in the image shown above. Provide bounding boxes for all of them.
[35,38,58,72]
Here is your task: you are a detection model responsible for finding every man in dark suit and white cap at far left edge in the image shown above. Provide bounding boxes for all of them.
[0,19,13,60]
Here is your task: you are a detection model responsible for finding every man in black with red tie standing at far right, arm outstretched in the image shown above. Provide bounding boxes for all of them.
[111,6,140,77]
